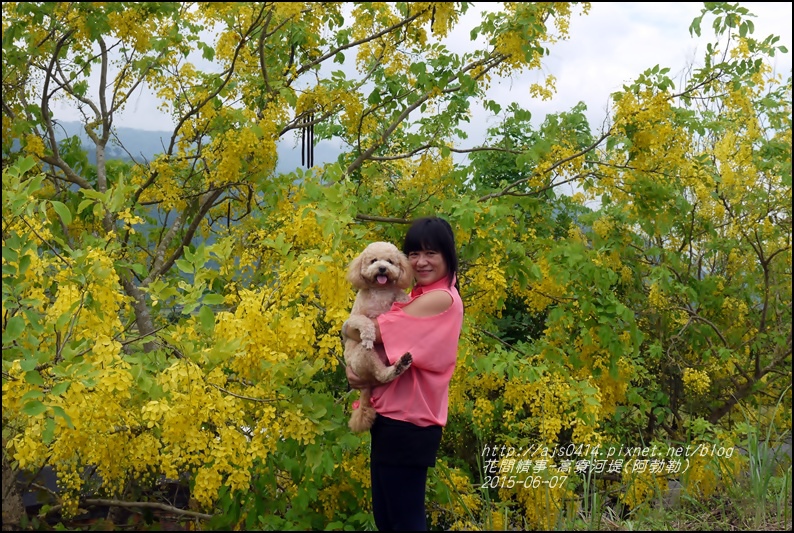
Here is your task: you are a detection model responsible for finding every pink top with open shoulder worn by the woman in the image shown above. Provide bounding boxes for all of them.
[371,277,463,427]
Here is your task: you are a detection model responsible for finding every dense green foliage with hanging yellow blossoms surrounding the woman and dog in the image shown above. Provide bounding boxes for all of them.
[2,2,792,529]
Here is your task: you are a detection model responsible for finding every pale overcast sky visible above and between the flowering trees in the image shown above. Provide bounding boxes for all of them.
[56,2,792,141]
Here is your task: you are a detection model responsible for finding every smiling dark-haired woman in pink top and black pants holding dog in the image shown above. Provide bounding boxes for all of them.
[346,217,463,531]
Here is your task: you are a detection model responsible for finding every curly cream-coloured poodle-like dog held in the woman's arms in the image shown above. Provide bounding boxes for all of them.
[342,242,413,433]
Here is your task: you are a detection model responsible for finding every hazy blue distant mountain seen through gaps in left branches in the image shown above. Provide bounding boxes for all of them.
[55,121,341,173]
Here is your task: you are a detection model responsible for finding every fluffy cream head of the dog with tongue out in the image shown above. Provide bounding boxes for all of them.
[347,242,413,289]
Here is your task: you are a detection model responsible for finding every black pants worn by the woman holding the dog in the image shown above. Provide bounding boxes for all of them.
[370,415,442,531]
